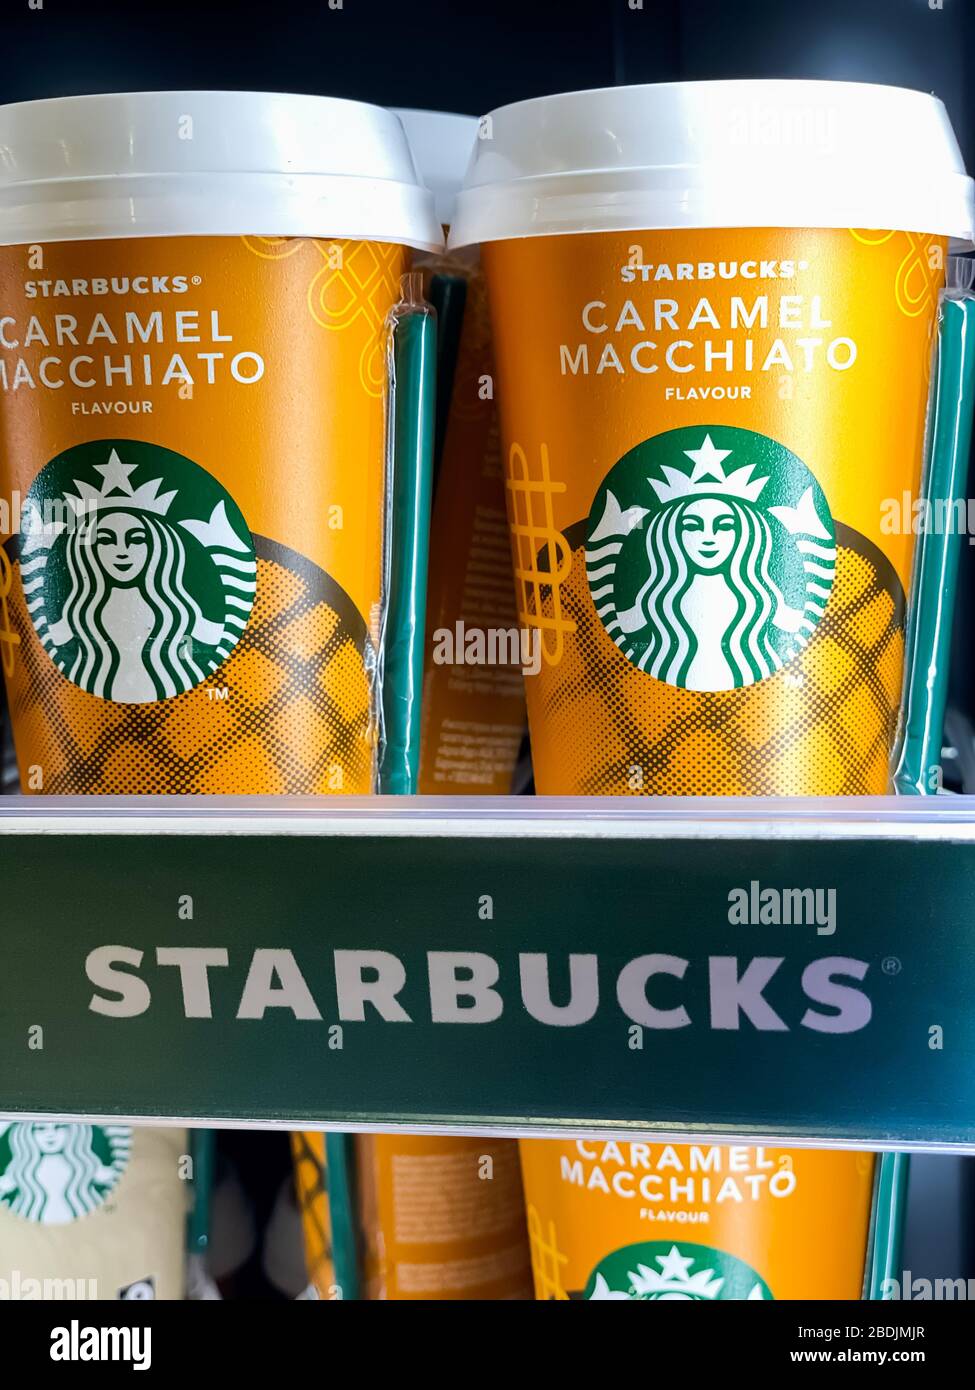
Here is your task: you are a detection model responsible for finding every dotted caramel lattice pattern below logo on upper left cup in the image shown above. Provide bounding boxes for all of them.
[2,537,376,795]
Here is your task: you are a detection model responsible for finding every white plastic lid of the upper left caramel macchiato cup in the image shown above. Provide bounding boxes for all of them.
[0,92,442,250]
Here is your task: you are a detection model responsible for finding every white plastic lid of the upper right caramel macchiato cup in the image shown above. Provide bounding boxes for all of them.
[451,81,975,246]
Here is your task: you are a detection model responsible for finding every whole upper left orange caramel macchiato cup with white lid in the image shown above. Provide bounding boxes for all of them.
[0,92,441,794]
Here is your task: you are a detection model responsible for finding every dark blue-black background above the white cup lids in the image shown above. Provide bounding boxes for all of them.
[0,0,975,167]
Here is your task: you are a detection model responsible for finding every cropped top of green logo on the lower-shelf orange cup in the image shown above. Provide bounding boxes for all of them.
[583,1240,773,1302]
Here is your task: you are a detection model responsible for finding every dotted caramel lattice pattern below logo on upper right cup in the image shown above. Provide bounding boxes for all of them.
[529,525,904,796]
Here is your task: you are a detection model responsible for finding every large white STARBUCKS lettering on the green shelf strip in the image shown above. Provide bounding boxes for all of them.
[85,945,872,1034]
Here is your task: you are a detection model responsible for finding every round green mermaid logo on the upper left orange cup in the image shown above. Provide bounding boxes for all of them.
[21,439,257,705]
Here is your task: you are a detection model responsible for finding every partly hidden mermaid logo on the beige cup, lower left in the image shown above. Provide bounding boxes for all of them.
[0,1122,132,1226]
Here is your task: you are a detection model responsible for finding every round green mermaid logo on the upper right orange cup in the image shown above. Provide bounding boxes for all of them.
[586,425,836,691]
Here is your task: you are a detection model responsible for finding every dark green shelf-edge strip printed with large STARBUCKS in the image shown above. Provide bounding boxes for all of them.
[0,815,975,1147]
